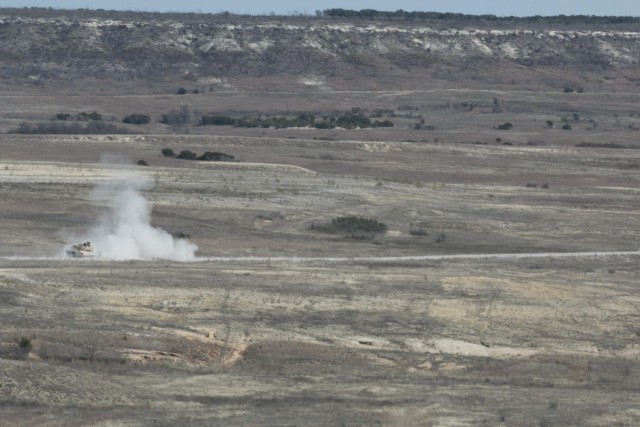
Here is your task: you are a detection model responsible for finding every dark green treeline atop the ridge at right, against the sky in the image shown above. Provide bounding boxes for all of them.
[316,9,640,24]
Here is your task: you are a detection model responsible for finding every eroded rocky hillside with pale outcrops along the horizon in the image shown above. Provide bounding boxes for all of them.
[0,10,640,85]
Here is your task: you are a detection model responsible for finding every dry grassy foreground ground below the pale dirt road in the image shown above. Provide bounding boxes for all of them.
[0,256,640,425]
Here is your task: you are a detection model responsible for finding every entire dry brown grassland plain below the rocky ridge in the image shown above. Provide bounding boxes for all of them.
[0,10,640,427]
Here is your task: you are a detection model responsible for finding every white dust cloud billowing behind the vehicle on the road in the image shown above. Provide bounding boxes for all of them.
[65,159,198,261]
